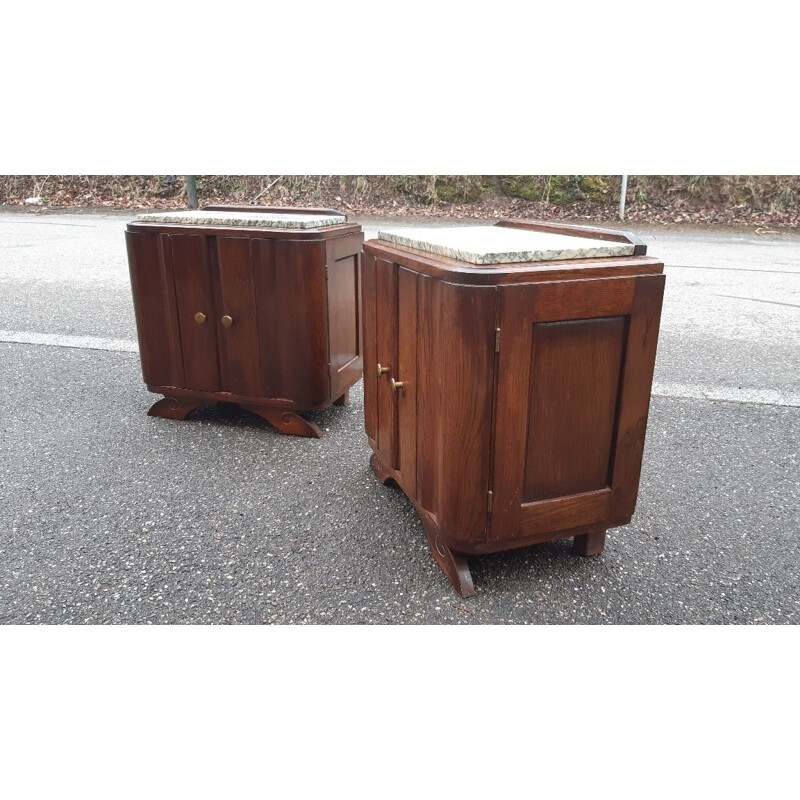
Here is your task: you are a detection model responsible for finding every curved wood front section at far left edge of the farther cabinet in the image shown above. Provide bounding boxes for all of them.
[125,231,182,386]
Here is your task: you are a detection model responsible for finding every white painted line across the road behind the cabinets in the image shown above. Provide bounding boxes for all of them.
[0,330,800,407]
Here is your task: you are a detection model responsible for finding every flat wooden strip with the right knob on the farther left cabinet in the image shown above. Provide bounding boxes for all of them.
[213,237,262,397]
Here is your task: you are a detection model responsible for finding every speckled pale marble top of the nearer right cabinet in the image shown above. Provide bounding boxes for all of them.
[378,225,634,265]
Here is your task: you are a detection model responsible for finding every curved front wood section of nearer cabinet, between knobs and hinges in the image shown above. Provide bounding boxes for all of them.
[420,281,497,549]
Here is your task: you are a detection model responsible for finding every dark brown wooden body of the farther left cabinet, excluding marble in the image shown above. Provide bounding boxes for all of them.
[126,207,364,437]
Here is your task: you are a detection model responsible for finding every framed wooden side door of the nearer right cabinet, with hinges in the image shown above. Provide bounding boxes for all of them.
[490,275,664,540]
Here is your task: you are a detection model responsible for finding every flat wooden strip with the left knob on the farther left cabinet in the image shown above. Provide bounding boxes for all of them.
[165,235,220,392]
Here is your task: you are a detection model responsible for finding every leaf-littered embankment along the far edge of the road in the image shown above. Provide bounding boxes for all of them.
[0,175,800,229]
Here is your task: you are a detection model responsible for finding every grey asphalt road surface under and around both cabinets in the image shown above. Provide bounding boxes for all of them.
[0,212,800,624]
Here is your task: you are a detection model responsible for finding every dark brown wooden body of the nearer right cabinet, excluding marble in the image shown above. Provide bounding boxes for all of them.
[362,222,664,596]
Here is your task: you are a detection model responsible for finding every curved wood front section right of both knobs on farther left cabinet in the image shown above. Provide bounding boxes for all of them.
[253,239,334,410]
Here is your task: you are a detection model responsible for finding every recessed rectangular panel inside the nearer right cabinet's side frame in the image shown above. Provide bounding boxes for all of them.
[522,317,626,503]
